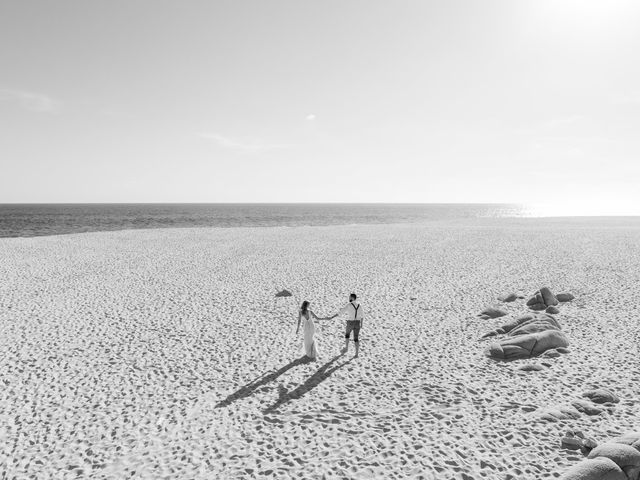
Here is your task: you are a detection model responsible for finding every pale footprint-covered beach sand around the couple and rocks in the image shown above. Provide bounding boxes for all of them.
[0,220,640,480]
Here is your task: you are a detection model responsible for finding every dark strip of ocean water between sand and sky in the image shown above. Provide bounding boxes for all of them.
[0,203,530,237]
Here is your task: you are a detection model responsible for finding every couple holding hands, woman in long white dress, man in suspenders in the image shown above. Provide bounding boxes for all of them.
[296,293,364,359]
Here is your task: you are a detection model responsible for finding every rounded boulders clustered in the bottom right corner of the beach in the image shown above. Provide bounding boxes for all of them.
[560,432,640,480]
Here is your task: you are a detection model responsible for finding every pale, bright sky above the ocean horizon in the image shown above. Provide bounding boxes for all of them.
[0,0,640,214]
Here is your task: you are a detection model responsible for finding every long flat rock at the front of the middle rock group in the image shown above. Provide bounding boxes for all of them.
[487,330,569,360]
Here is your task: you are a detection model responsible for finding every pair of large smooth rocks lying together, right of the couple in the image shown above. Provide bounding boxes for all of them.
[483,314,569,360]
